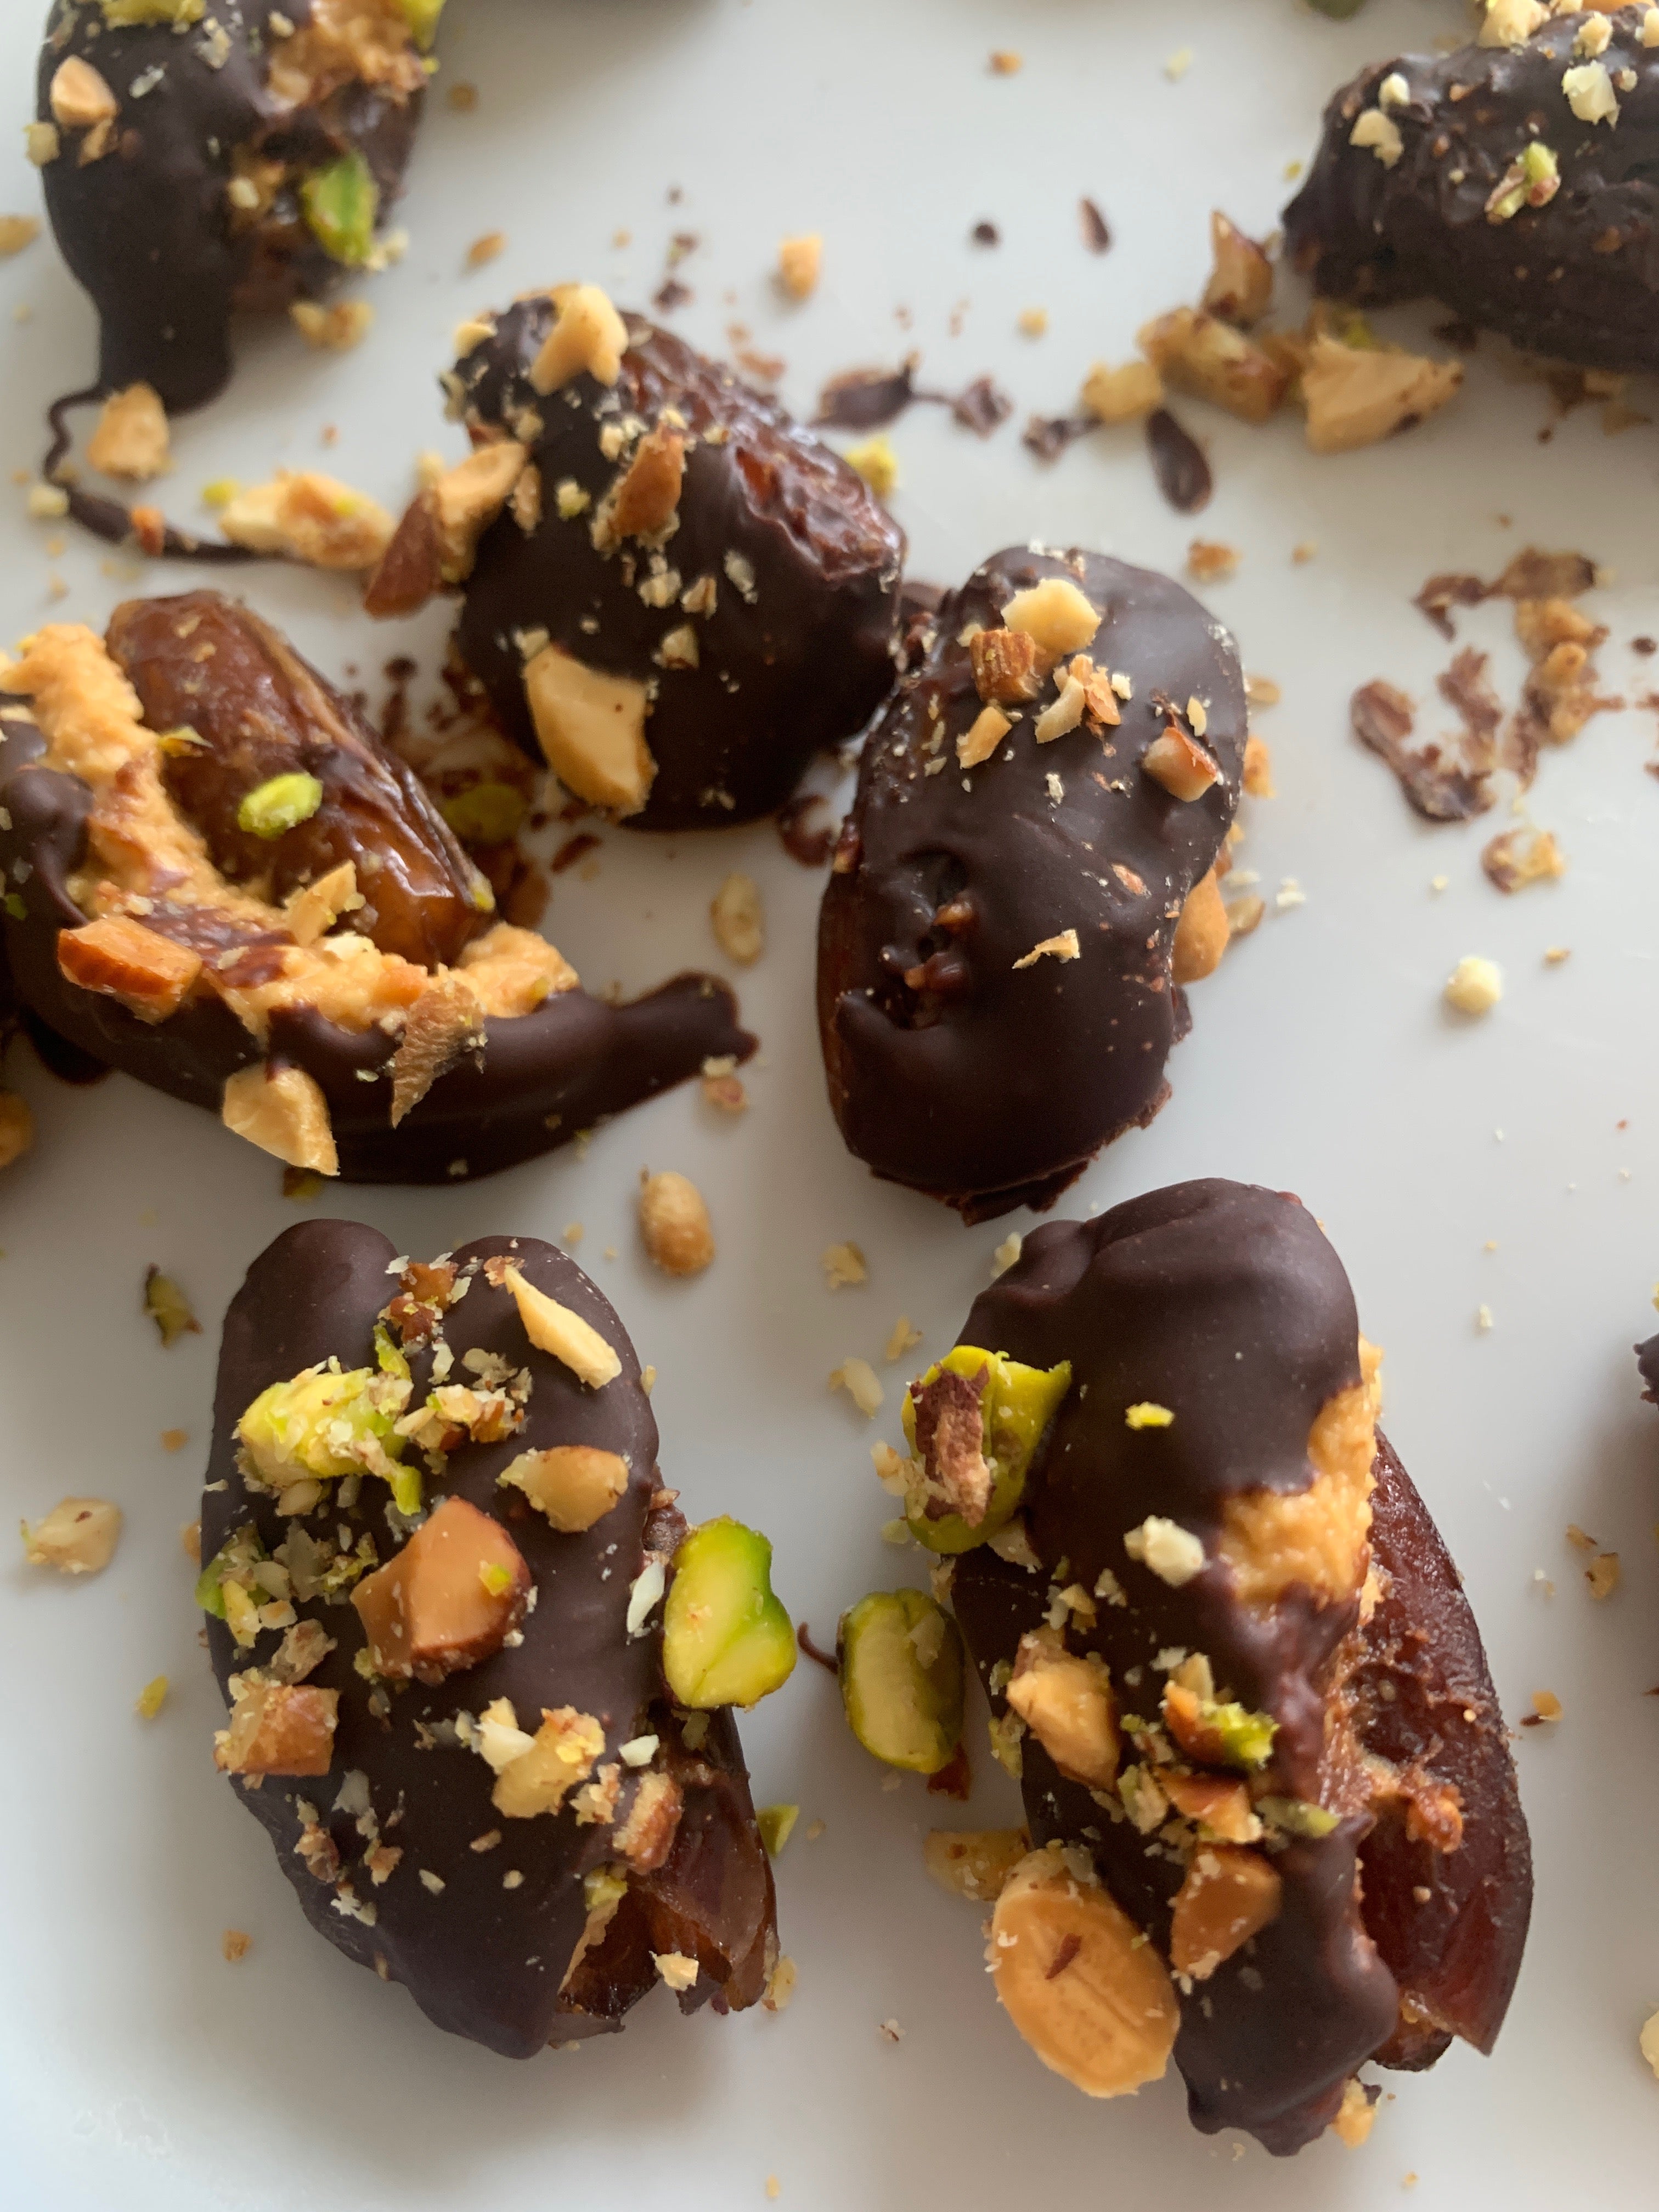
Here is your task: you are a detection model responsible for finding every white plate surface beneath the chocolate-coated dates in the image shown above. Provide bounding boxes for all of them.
[0,0,1659,2212]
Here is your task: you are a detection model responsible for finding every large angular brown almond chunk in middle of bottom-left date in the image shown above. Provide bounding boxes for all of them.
[352,1498,531,1683]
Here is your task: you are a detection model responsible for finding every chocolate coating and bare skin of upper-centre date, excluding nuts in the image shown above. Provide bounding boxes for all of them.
[454,296,905,830]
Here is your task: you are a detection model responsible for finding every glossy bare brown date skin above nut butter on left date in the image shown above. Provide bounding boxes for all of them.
[106,591,493,967]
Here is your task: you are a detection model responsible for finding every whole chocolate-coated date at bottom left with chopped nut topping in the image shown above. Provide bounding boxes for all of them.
[197,1221,787,2057]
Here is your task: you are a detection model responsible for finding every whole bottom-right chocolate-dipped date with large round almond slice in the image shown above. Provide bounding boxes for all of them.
[898,1181,1531,2154]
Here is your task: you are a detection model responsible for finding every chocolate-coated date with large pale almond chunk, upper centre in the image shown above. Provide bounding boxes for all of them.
[367,285,905,830]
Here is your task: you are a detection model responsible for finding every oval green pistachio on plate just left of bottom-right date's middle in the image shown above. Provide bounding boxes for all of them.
[836,1590,964,1774]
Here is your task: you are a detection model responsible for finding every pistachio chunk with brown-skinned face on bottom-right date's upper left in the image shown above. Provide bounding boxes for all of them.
[902,1345,1070,1553]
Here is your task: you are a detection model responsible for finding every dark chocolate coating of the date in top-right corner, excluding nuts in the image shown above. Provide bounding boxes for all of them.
[1285,7,1659,369]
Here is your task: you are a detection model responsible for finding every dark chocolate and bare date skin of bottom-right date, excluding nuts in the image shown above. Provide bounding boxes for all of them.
[953,1181,1531,2154]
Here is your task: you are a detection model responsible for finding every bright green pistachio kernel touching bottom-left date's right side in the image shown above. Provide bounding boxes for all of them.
[662,1515,797,1712]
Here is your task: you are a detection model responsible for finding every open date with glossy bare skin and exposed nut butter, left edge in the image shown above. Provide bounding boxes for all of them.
[0,593,754,1181]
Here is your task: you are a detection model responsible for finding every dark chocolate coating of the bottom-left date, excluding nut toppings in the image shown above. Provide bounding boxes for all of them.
[201,1221,776,2057]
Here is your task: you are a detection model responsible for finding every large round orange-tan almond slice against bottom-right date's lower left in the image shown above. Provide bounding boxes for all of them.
[986,1849,1179,2097]
